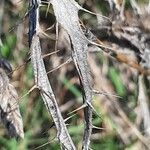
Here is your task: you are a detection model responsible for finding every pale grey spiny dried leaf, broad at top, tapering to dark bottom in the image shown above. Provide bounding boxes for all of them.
[51,0,92,150]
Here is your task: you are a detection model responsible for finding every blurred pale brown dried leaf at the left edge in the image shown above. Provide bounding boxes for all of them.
[0,68,24,138]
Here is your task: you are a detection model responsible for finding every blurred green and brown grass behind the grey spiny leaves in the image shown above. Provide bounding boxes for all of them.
[0,0,150,150]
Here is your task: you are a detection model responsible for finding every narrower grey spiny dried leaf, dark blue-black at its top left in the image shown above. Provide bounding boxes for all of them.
[29,0,76,150]
